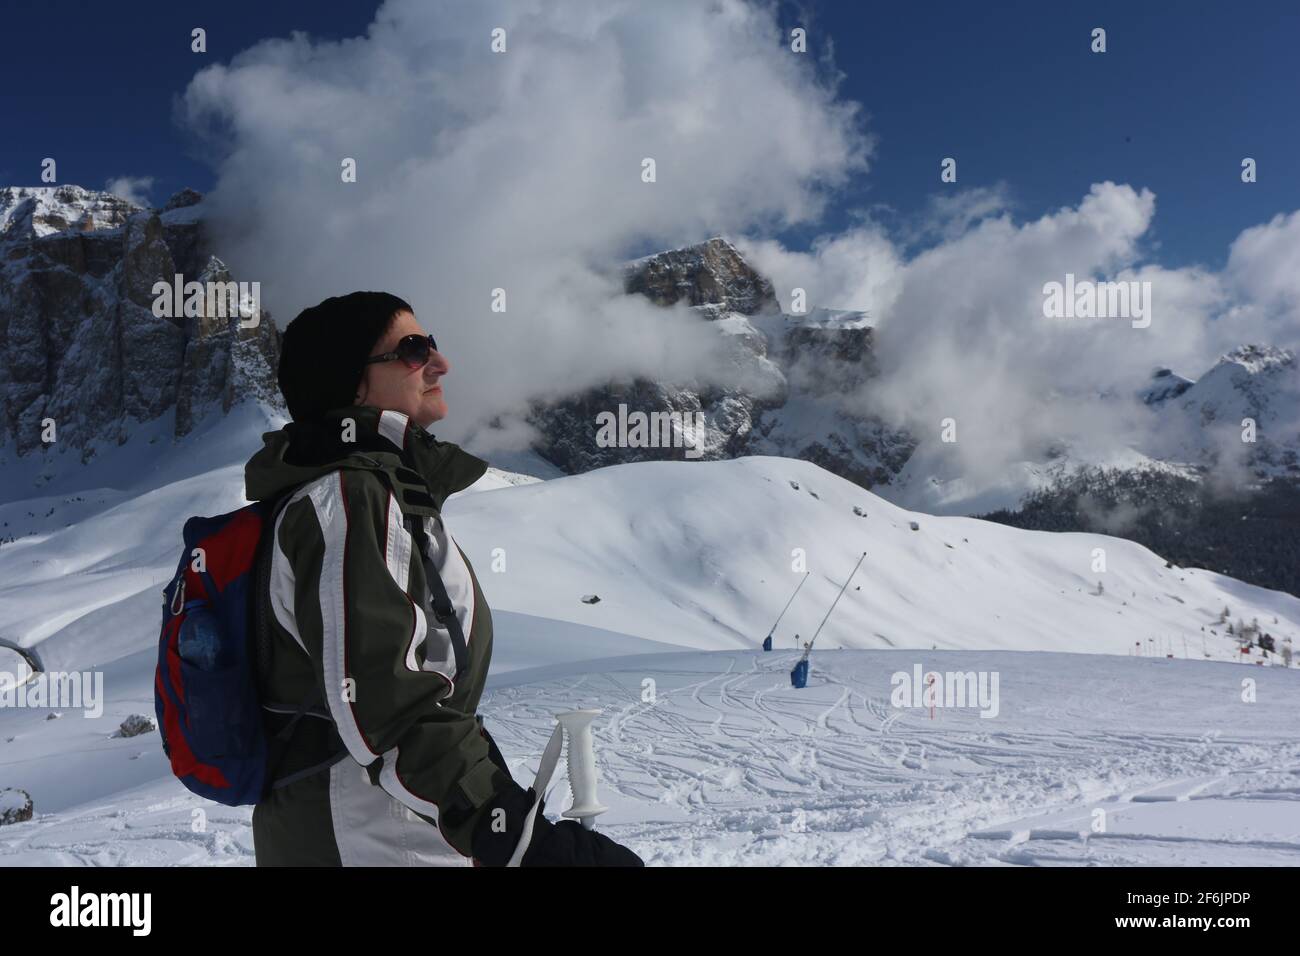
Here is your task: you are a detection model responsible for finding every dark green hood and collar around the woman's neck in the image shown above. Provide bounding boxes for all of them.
[244,405,488,509]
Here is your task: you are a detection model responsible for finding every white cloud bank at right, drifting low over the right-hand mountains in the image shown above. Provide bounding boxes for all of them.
[744,182,1300,486]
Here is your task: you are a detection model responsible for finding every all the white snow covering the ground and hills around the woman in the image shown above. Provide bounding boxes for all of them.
[0,406,1300,865]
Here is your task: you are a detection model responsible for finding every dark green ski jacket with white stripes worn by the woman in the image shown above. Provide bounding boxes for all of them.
[244,406,511,866]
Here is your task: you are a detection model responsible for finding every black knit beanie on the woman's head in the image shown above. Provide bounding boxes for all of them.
[278,293,415,421]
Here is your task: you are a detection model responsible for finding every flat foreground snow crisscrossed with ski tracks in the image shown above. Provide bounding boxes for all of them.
[0,650,1300,866]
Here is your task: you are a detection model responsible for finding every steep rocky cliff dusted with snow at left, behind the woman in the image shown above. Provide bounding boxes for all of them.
[0,186,281,467]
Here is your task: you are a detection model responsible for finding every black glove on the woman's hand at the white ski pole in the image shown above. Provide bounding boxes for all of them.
[471,782,645,866]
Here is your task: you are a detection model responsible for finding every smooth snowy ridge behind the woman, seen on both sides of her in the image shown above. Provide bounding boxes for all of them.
[0,411,1300,681]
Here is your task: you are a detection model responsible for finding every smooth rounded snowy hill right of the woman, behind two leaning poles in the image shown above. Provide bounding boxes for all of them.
[449,458,1300,656]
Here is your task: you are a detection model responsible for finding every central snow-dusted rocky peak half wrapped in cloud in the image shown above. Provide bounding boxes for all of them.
[529,237,915,488]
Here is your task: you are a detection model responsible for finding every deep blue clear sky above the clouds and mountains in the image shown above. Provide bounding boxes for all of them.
[0,0,1300,268]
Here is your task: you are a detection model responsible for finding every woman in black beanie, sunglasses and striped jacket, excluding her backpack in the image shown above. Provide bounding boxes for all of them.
[244,293,641,866]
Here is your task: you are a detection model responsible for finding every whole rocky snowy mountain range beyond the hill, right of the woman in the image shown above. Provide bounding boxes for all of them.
[530,237,1300,514]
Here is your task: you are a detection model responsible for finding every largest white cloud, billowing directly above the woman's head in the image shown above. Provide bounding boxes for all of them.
[178,0,872,438]
